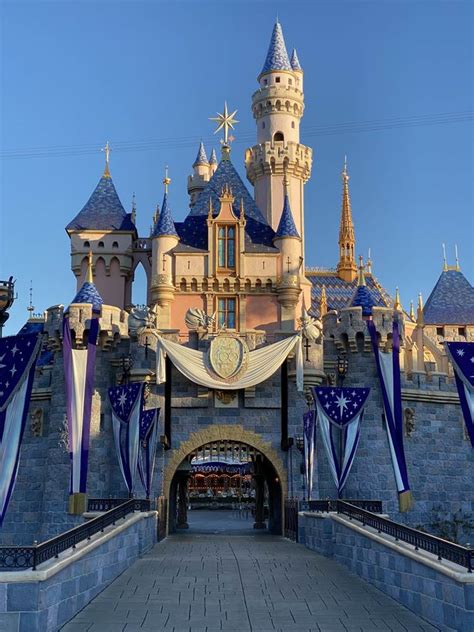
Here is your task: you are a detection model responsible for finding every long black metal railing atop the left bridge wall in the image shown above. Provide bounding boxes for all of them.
[0,498,150,570]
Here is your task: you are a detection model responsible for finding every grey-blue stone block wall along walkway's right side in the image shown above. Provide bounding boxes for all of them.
[299,513,474,632]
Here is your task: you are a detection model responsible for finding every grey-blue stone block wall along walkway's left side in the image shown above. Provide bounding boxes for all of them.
[0,512,157,632]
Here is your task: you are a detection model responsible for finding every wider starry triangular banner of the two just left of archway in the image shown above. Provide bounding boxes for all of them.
[109,382,143,496]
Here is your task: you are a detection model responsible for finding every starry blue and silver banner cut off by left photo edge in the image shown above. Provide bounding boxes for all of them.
[0,334,41,526]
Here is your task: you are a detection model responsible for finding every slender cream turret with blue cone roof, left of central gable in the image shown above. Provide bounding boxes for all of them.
[150,168,179,329]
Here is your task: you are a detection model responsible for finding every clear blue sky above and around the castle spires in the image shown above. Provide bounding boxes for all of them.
[0,0,474,333]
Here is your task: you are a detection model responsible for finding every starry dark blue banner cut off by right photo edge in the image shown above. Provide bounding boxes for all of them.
[445,342,474,448]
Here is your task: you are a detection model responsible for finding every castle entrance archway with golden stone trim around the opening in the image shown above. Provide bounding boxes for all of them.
[164,426,286,535]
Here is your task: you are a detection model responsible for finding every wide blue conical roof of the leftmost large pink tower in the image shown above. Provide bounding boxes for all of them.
[66,174,136,231]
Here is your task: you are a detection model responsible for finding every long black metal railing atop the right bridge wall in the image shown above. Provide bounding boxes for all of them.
[337,500,474,573]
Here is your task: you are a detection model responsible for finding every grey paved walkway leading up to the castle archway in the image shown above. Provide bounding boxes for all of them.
[62,534,436,632]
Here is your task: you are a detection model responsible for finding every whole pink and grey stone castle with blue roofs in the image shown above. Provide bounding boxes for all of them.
[0,22,474,544]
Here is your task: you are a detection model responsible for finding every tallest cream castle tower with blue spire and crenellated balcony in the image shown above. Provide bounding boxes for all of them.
[245,22,312,256]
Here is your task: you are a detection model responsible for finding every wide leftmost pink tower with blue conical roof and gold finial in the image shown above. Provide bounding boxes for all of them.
[66,143,137,309]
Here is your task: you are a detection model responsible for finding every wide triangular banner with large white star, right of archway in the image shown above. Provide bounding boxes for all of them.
[313,386,370,498]
